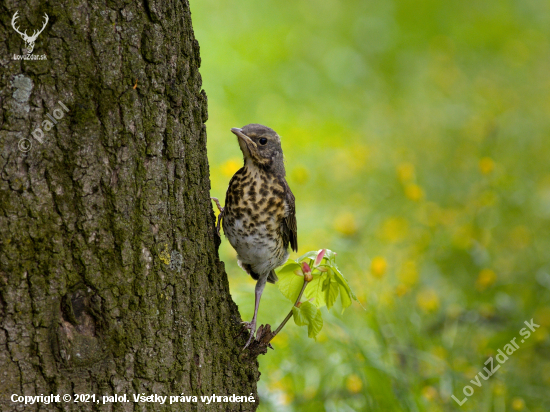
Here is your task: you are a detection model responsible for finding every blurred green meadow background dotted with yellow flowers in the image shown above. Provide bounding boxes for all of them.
[191,0,550,412]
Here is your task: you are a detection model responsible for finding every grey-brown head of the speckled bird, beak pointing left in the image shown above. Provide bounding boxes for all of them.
[231,124,285,176]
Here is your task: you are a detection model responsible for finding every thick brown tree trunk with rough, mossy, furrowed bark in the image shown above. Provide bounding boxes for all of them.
[0,0,259,411]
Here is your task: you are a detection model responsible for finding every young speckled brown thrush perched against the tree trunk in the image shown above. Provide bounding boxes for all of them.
[215,124,298,349]
